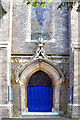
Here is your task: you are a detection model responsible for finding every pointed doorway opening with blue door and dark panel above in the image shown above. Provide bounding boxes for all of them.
[27,70,53,112]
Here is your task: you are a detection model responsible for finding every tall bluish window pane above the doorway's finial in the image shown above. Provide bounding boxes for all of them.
[31,4,50,40]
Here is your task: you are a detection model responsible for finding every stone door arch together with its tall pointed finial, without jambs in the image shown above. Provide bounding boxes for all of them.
[16,39,64,85]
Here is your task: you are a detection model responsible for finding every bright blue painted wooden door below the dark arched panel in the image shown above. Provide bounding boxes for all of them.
[27,86,53,112]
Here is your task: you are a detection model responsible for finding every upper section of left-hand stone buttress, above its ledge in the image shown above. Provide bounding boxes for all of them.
[0,0,10,42]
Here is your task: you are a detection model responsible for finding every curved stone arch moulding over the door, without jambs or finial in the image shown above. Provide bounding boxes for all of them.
[16,59,64,85]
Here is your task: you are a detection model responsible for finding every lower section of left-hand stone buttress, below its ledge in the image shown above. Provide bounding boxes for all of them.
[0,47,10,118]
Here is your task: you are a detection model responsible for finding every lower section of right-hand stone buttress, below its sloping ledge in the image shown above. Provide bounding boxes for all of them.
[72,46,80,117]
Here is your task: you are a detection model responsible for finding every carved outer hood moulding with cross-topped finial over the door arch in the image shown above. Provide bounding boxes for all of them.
[16,38,64,84]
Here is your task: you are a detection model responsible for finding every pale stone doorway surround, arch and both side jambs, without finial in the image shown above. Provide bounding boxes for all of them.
[16,59,64,111]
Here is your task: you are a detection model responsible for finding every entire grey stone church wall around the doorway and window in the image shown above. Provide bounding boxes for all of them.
[0,0,80,117]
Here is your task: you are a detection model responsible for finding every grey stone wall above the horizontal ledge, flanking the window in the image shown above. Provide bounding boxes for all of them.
[12,0,69,55]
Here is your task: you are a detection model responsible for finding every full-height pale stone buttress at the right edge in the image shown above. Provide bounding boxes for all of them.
[68,3,80,118]
